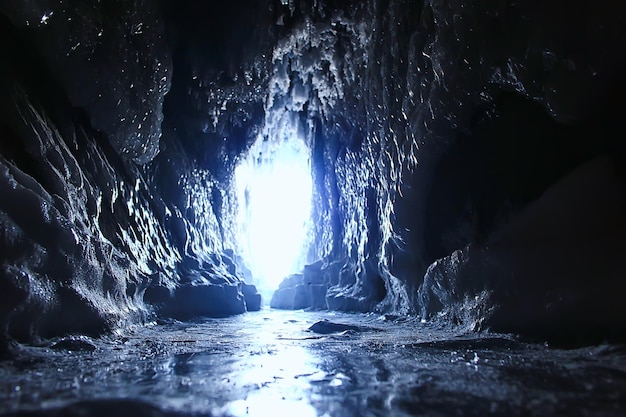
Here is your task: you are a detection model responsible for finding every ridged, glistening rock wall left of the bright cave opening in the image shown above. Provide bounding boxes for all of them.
[0,2,260,348]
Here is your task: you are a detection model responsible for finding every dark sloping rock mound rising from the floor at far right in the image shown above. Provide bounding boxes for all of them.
[418,157,626,342]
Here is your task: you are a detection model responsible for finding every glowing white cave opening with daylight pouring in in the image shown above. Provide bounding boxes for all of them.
[234,134,313,295]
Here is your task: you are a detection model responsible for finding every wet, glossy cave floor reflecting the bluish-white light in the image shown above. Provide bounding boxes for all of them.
[0,309,626,417]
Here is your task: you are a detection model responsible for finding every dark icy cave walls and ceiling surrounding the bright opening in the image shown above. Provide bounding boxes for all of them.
[0,0,626,416]
